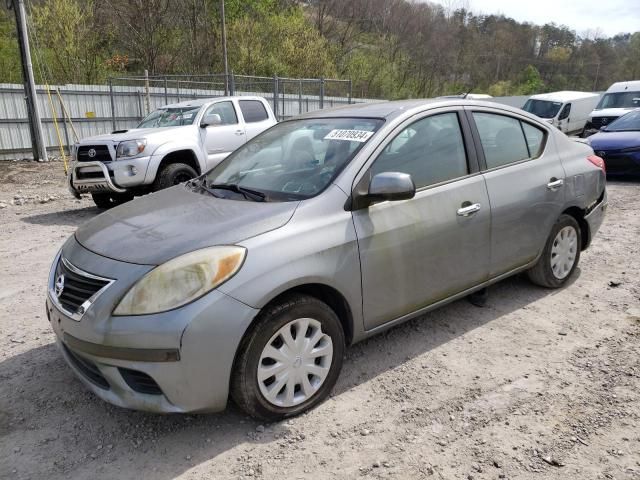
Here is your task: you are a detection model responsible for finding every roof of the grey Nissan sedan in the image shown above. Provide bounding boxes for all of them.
[295,98,526,120]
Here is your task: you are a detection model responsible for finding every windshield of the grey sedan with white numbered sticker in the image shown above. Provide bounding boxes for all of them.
[204,118,383,201]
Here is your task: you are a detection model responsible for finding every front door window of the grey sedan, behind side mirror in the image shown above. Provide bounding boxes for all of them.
[371,113,469,188]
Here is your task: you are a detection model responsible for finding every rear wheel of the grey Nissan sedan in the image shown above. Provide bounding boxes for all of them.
[527,214,582,288]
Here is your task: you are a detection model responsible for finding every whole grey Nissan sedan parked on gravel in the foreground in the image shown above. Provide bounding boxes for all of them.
[46,99,607,420]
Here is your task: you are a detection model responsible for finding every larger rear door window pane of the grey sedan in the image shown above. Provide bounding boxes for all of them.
[473,112,529,168]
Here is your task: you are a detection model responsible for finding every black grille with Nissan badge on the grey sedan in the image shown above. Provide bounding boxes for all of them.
[53,256,110,314]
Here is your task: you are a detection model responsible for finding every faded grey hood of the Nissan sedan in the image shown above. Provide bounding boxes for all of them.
[75,185,299,265]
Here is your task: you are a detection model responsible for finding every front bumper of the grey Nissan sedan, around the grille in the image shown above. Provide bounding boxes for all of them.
[46,241,258,413]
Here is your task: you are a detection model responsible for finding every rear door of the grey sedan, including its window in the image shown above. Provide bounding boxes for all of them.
[468,108,565,278]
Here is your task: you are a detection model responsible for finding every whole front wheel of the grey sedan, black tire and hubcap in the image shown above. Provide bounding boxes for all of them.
[231,295,346,421]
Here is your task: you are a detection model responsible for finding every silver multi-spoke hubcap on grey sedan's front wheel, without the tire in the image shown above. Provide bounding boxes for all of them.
[258,318,333,407]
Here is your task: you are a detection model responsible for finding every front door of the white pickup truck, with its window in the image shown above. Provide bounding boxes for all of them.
[200,100,246,169]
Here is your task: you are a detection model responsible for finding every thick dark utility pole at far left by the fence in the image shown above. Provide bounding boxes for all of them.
[12,0,48,162]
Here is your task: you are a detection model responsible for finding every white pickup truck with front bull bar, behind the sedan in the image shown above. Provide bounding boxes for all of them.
[69,97,276,208]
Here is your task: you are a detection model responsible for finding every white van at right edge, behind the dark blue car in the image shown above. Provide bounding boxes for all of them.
[584,80,640,136]
